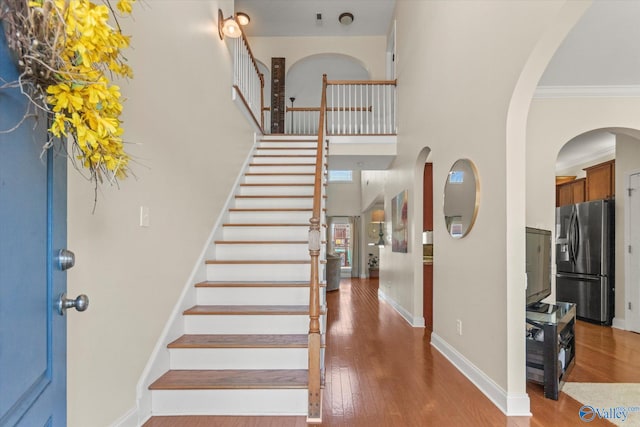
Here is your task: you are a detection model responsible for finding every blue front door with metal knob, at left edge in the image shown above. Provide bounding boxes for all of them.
[0,26,67,427]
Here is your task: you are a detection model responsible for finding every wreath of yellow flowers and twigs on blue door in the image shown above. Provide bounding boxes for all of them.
[0,0,135,183]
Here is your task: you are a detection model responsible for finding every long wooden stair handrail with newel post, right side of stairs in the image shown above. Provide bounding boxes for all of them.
[307,74,327,422]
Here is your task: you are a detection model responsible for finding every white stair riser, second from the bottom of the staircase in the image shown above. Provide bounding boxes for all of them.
[169,348,309,370]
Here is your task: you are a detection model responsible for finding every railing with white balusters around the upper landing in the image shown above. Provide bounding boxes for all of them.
[233,34,397,136]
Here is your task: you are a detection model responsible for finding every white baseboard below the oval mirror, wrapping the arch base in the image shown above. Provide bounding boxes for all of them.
[431,333,531,417]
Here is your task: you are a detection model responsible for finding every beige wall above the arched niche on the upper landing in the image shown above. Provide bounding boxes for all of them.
[249,36,387,80]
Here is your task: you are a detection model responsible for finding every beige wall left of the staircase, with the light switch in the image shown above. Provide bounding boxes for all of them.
[68,0,253,427]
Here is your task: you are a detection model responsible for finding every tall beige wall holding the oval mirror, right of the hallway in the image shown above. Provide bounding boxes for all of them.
[362,0,588,411]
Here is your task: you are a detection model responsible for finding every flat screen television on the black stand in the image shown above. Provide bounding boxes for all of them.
[526,227,551,310]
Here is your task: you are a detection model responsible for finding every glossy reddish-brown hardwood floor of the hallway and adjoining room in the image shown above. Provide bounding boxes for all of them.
[145,279,640,427]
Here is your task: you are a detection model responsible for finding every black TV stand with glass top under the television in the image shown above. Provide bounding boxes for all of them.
[526,302,576,400]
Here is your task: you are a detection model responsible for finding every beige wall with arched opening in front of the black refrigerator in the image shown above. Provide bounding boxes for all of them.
[526,97,640,326]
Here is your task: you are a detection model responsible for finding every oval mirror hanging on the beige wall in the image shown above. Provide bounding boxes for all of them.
[444,159,480,239]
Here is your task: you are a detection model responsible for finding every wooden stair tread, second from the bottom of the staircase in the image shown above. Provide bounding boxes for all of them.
[168,334,309,348]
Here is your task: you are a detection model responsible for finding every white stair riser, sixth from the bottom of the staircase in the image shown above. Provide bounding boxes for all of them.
[216,243,309,261]
